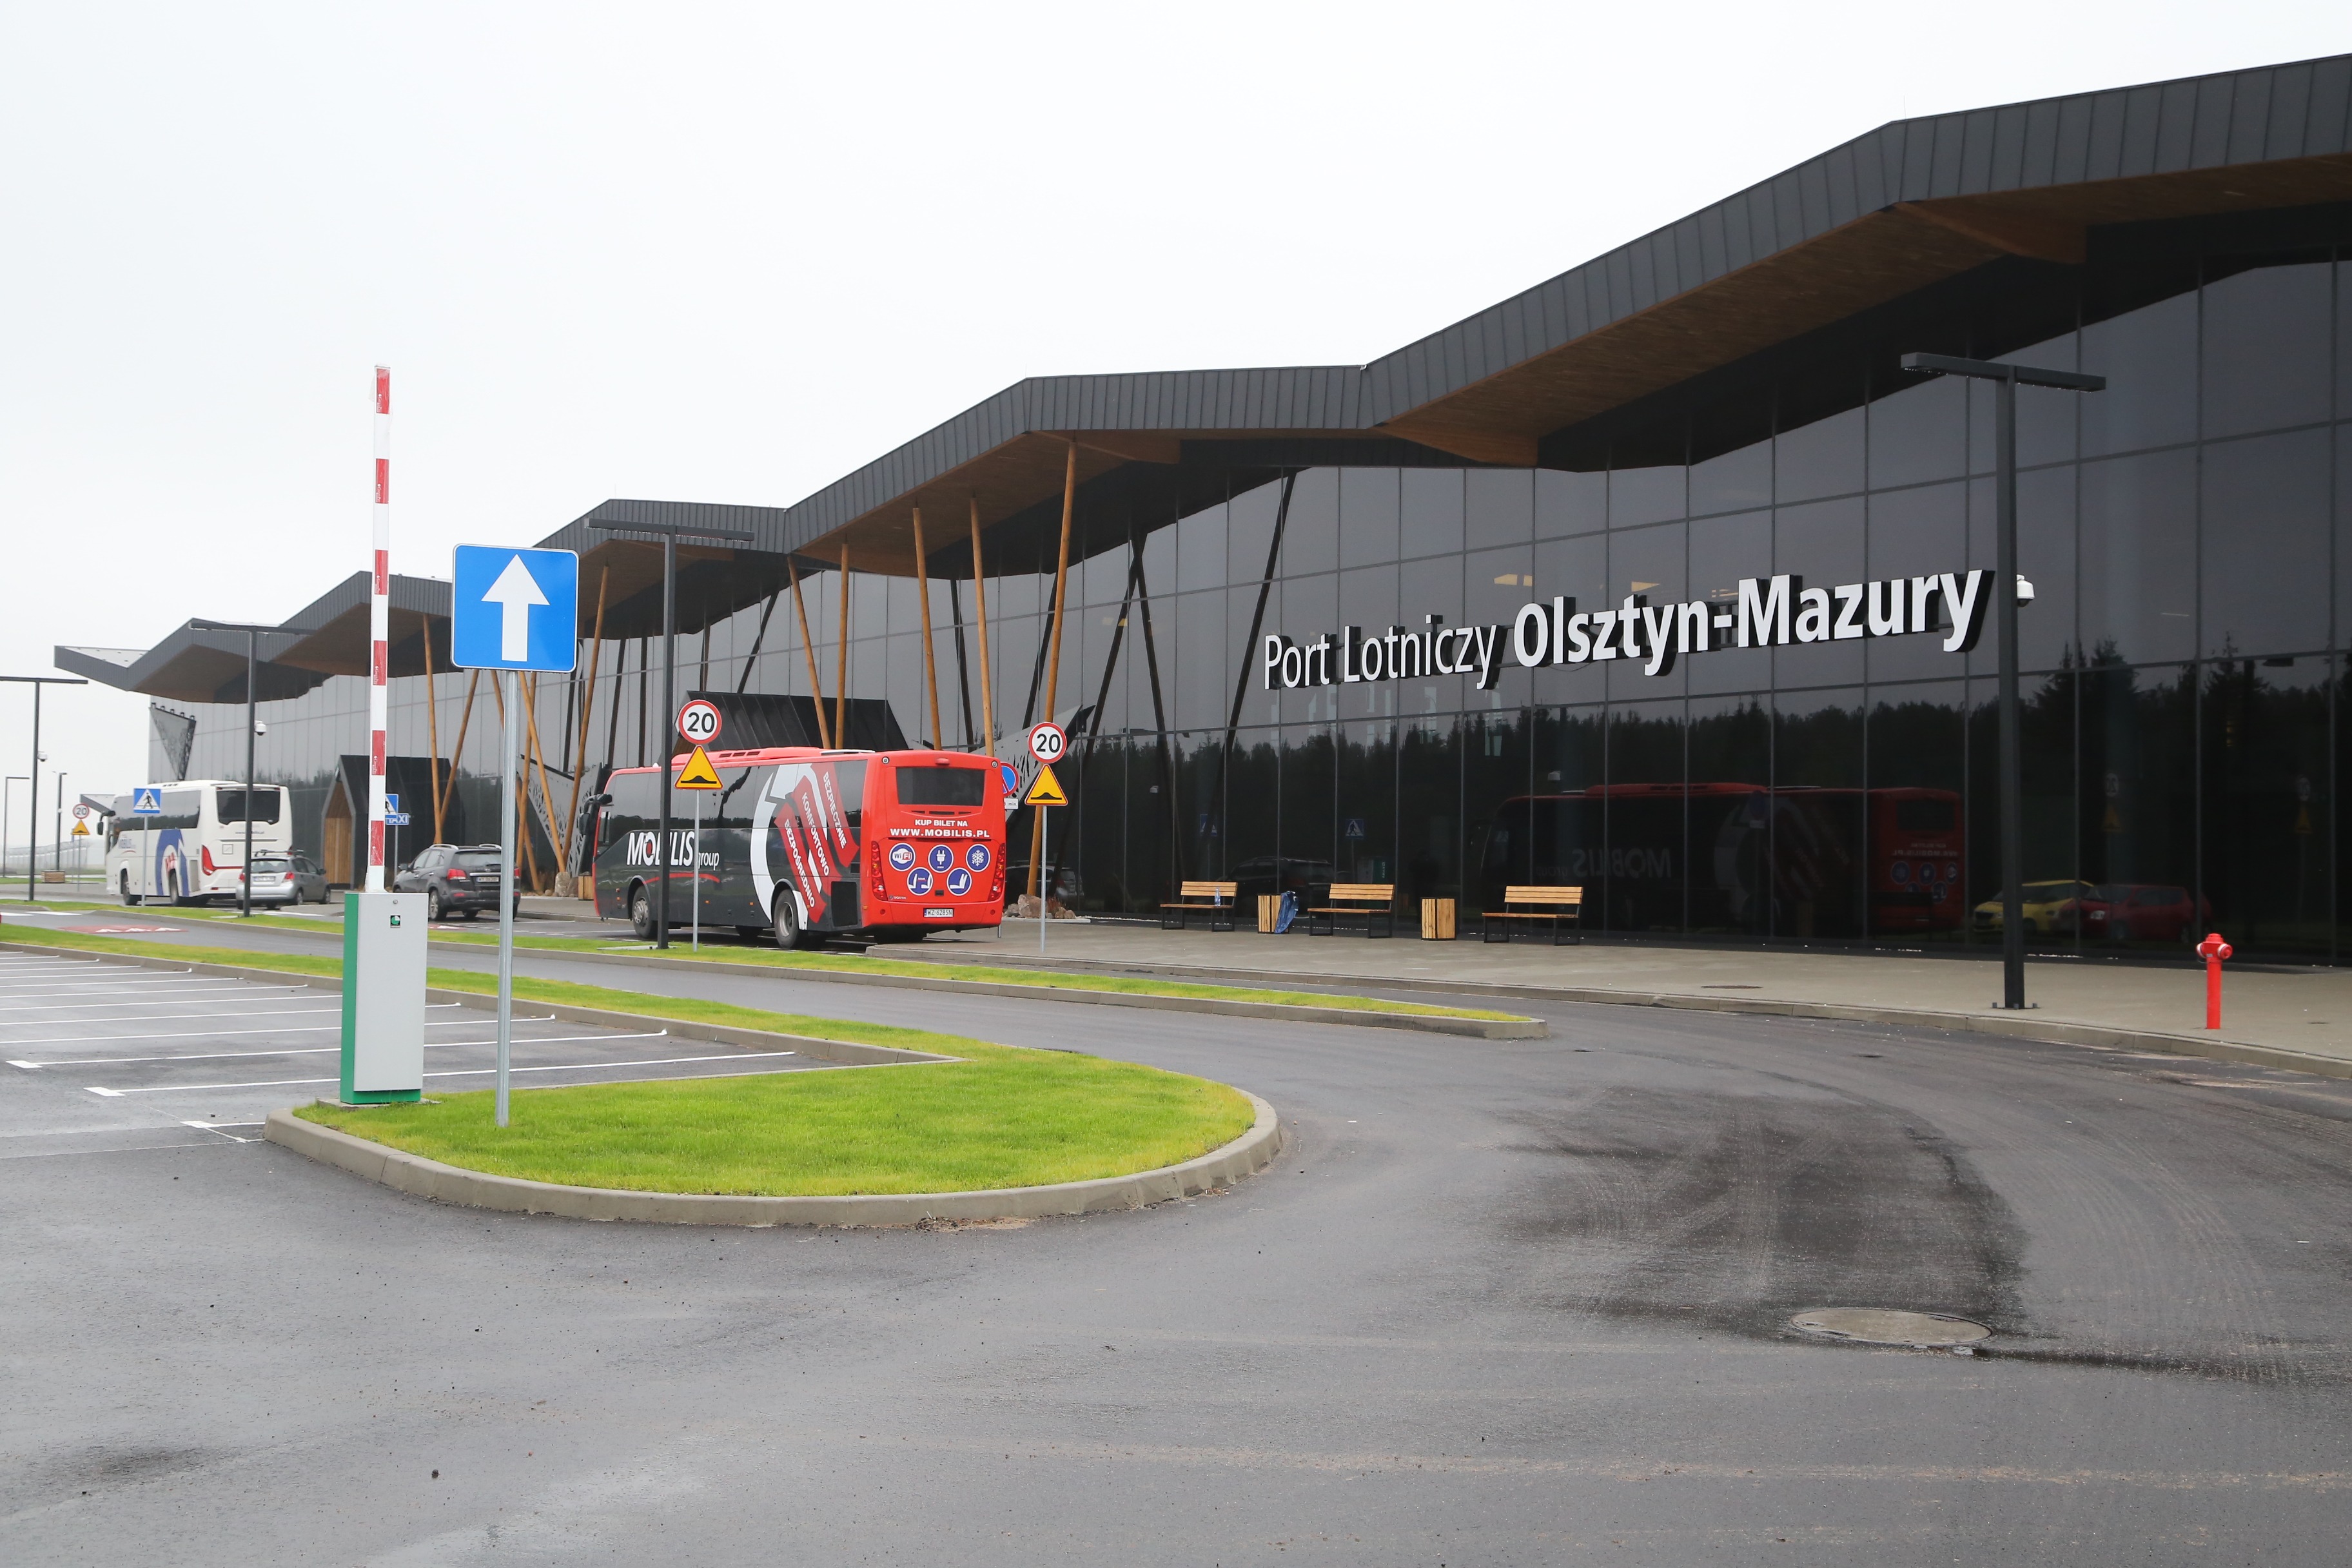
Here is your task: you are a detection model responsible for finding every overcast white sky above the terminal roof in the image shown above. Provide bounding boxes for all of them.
[0,0,2352,832]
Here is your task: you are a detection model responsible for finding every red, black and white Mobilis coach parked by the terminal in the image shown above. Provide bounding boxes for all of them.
[595,745,1004,947]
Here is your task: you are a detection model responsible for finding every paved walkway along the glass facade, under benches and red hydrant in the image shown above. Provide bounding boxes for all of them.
[912,921,2352,1074]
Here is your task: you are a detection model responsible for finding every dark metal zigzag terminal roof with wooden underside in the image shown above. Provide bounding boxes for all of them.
[59,54,2352,677]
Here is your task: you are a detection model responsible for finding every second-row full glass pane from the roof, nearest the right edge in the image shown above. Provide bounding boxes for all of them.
[2202,430,2329,658]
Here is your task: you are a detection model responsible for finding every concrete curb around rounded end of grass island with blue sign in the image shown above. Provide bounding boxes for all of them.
[264,1091,1282,1227]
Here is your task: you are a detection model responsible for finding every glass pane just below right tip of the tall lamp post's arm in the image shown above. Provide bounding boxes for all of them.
[2081,447,2197,665]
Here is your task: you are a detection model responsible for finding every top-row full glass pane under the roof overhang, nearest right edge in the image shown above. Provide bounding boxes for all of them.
[2204,263,2333,437]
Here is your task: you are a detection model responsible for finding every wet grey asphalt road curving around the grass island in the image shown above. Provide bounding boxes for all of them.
[0,912,2352,1565]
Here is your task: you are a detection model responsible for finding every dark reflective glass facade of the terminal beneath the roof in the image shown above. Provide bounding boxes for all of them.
[173,216,2352,961]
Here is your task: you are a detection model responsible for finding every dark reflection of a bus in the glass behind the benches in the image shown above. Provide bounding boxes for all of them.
[1473,783,1966,938]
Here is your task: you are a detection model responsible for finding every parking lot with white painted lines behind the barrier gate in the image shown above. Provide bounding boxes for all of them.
[0,954,830,1154]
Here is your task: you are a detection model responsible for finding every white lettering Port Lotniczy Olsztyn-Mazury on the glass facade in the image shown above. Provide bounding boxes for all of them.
[1259,569,2032,691]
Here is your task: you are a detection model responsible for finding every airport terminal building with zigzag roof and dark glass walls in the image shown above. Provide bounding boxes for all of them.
[57,57,2352,961]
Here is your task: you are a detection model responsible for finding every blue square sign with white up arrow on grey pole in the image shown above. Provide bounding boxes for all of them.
[449,545,578,1126]
